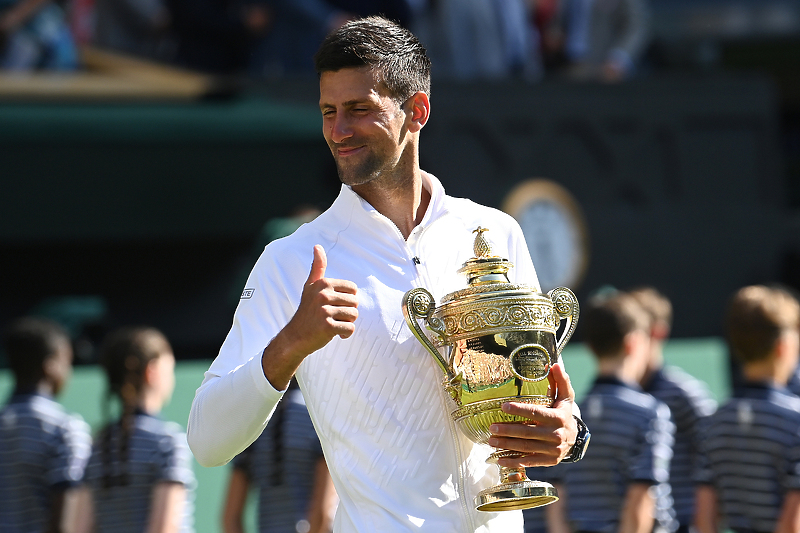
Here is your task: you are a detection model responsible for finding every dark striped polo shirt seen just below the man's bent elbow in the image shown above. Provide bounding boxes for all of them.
[233,389,322,533]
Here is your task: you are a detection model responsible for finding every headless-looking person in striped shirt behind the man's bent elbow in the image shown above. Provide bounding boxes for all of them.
[222,380,338,533]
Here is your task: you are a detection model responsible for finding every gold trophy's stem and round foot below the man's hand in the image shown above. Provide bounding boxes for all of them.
[475,450,558,512]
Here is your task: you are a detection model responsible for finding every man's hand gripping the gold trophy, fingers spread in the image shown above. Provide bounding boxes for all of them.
[489,364,578,468]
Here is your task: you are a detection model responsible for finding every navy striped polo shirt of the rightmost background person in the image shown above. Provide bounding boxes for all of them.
[696,382,800,532]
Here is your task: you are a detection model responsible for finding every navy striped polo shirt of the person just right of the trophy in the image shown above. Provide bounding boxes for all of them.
[564,377,677,532]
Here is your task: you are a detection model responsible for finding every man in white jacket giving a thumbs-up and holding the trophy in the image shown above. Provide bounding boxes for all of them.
[188,17,577,533]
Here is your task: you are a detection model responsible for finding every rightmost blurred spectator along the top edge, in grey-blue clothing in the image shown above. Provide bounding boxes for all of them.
[566,0,650,82]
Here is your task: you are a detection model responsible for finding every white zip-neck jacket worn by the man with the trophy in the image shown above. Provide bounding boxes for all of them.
[188,173,538,533]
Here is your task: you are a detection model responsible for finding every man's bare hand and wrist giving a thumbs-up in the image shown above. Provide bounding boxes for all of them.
[261,245,358,390]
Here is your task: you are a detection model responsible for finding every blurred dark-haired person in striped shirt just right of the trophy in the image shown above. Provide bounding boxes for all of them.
[550,292,675,533]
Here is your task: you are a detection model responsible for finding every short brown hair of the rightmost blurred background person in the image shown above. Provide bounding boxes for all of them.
[725,285,800,363]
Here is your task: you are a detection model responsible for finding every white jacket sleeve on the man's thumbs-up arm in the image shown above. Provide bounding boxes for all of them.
[186,241,310,466]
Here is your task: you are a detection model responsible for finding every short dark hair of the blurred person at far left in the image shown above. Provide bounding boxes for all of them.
[3,317,69,384]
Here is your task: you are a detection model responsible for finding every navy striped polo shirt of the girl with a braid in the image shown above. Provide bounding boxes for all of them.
[86,413,195,533]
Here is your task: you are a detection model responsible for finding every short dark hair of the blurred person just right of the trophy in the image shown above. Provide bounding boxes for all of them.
[581,292,650,359]
